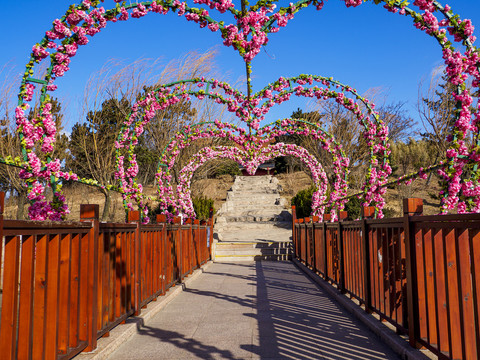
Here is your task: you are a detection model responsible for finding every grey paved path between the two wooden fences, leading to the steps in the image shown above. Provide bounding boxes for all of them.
[110,262,399,360]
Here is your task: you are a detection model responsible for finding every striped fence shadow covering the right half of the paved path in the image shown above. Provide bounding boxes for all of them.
[248,262,399,360]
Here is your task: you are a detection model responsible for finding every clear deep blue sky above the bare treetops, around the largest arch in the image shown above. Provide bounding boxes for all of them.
[0,0,480,129]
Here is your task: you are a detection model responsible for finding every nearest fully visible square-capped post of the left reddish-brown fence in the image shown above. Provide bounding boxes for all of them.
[80,204,100,352]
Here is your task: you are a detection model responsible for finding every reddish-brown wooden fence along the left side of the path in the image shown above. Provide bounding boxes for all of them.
[0,200,213,359]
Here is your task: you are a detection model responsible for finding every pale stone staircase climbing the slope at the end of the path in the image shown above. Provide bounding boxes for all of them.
[214,175,292,261]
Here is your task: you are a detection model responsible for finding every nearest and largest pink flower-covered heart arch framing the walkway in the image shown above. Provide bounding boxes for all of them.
[6,0,480,220]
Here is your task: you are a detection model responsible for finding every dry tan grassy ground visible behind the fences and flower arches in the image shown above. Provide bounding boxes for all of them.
[4,171,440,222]
